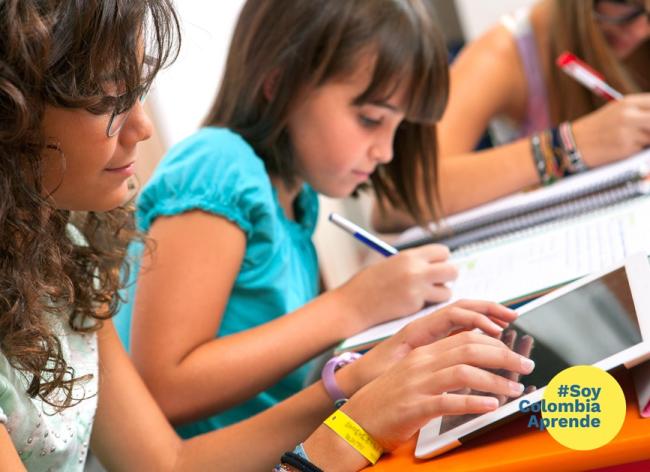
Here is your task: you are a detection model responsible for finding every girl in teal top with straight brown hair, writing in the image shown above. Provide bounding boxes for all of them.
[118,0,516,442]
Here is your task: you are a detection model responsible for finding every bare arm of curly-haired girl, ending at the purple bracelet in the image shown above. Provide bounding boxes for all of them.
[92,322,347,472]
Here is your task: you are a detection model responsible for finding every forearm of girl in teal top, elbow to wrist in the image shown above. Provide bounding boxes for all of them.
[140,292,360,423]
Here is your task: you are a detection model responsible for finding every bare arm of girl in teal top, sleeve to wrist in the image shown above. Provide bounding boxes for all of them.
[132,211,352,422]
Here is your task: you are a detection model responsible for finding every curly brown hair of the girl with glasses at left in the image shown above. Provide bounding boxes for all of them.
[0,0,180,408]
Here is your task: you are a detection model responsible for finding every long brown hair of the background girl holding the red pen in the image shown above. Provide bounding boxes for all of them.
[547,0,650,123]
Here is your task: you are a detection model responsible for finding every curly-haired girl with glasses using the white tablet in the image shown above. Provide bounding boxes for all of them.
[0,0,521,472]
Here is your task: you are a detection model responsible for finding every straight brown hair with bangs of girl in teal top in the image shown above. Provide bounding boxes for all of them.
[205,0,449,222]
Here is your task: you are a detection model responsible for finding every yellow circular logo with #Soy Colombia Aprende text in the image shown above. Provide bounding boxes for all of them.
[540,365,625,451]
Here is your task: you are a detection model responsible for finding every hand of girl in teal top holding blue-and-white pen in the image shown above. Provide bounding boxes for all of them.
[330,214,458,332]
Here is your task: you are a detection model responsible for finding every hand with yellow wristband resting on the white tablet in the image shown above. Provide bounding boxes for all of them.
[342,324,534,450]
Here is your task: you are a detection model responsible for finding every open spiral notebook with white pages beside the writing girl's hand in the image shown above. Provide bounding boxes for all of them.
[336,151,650,352]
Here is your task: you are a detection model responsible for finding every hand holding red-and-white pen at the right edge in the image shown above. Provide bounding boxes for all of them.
[557,53,650,167]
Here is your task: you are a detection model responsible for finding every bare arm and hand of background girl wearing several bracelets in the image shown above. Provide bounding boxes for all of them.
[373,21,650,232]
